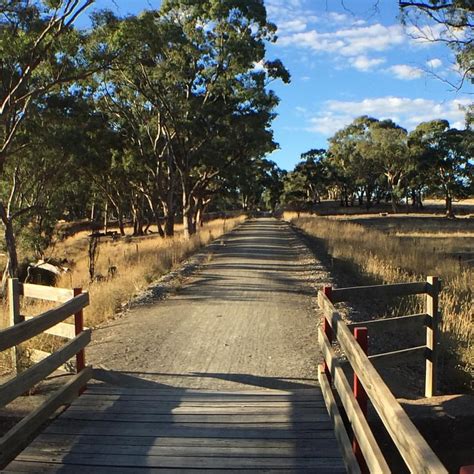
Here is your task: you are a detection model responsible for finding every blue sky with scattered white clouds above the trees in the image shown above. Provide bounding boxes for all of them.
[78,0,474,170]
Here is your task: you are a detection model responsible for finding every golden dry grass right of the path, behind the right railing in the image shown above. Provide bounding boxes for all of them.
[284,213,474,392]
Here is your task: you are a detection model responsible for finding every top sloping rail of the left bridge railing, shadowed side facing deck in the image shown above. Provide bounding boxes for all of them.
[0,293,89,351]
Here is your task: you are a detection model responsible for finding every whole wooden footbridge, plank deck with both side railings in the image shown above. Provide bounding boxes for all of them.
[0,278,447,474]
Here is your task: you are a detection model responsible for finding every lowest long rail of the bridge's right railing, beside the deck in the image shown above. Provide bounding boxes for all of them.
[318,367,361,474]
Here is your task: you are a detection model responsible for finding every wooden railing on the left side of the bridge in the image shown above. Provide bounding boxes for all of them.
[0,279,92,467]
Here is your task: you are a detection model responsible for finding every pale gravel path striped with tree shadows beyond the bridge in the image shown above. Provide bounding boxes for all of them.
[88,218,327,389]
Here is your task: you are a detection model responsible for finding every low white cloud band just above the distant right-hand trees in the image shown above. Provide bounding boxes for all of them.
[307,96,471,136]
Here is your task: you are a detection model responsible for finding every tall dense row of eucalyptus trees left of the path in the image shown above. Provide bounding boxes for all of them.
[0,0,290,286]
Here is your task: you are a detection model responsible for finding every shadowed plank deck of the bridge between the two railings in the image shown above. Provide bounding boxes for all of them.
[5,384,346,474]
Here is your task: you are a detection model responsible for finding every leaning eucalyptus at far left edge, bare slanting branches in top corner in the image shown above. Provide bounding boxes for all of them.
[0,0,97,282]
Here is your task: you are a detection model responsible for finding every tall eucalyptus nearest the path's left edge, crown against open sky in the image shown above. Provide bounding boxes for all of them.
[150,0,289,235]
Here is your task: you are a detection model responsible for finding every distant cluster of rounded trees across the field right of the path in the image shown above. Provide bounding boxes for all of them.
[282,116,474,217]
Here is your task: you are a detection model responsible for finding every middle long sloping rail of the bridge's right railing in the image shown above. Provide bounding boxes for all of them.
[318,329,390,474]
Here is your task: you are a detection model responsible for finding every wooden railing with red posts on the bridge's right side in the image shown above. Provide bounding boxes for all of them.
[318,277,447,474]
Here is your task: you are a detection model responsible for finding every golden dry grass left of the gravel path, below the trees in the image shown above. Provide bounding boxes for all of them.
[0,216,245,372]
